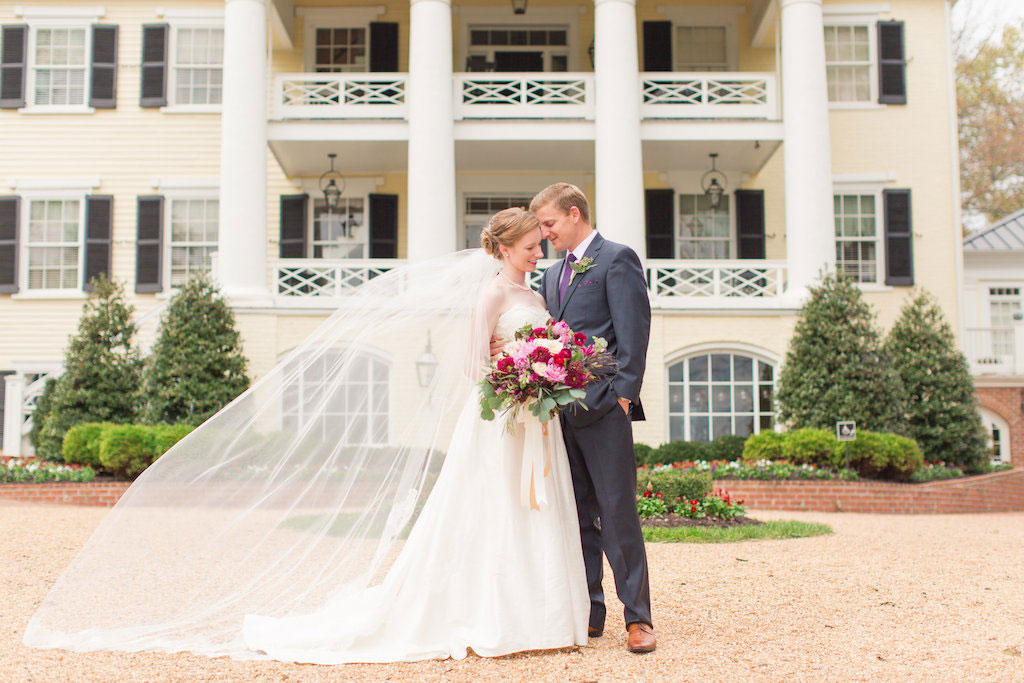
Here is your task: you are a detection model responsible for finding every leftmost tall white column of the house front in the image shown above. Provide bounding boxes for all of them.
[217,0,269,302]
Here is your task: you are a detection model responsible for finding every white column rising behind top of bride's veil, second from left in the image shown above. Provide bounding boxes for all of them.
[406,0,458,260]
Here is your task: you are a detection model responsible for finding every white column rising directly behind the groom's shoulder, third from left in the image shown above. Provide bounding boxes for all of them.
[594,0,646,258]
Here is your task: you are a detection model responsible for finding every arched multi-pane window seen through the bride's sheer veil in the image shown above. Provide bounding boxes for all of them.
[283,351,390,445]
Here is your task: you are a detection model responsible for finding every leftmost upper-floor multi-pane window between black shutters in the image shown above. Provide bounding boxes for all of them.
[32,27,88,105]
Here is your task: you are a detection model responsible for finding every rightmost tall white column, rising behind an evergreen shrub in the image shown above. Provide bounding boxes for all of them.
[781,0,836,298]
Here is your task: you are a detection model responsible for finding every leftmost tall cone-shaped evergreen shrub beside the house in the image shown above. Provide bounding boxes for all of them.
[42,274,142,458]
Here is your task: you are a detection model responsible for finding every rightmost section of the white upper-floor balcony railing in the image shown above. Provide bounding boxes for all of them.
[640,72,778,120]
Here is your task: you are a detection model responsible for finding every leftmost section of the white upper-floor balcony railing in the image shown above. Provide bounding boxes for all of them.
[273,74,409,120]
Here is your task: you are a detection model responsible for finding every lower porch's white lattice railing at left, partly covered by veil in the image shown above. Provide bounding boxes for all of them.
[270,258,404,300]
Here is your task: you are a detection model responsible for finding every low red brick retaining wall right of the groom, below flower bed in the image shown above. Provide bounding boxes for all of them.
[715,468,1024,514]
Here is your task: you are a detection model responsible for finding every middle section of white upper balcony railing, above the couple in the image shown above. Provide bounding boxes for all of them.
[455,73,594,119]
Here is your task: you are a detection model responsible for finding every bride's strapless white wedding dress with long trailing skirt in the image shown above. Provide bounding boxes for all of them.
[243,303,590,664]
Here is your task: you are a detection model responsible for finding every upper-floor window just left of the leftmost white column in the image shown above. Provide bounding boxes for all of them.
[172,27,224,104]
